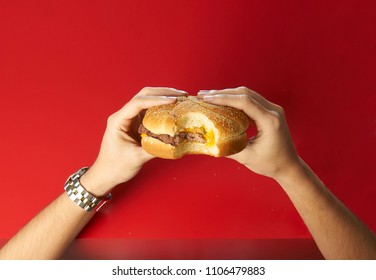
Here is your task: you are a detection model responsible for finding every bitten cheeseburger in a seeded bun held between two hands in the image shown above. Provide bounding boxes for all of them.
[138,96,249,159]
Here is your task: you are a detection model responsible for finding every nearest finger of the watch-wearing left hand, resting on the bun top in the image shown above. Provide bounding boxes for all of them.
[115,95,177,120]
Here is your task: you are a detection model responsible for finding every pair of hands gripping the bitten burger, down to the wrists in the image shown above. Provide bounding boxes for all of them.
[81,87,299,196]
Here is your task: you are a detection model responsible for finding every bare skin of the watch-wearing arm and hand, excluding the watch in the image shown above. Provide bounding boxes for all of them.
[0,88,187,259]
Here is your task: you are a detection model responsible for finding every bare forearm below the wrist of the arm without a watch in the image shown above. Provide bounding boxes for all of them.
[277,161,376,259]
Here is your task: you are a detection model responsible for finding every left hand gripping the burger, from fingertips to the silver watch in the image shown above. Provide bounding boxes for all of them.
[80,87,187,196]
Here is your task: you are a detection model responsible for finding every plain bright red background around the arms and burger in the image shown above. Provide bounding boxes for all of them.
[0,0,376,258]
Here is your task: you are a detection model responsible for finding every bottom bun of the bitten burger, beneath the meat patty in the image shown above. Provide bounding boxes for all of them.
[141,132,248,159]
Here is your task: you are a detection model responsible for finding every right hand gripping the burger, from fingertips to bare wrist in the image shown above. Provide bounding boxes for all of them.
[198,87,300,179]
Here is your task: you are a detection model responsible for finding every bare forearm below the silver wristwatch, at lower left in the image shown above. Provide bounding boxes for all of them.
[0,193,95,259]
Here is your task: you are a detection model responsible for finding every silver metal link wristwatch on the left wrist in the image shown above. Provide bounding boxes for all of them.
[64,167,112,212]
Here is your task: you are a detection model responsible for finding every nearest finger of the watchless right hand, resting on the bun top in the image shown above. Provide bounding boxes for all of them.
[203,94,269,126]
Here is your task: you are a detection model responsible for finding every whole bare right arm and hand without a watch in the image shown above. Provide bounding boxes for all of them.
[199,87,376,259]
